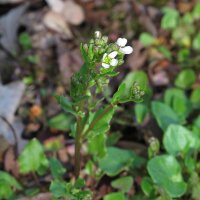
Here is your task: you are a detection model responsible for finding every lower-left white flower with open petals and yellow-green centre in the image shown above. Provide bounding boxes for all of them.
[102,51,118,69]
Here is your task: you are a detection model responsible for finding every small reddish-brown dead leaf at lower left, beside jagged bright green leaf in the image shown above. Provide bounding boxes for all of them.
[4,147,19,177]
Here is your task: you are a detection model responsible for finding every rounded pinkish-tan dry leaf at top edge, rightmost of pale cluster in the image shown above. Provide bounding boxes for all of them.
[62,0,85,25]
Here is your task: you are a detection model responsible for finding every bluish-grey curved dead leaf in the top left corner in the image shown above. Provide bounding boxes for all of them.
[0,4,29,53]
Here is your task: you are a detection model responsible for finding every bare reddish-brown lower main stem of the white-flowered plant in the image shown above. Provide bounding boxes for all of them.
[75,116,82,178]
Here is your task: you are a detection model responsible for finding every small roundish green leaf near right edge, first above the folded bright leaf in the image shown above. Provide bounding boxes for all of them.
[175,69,196,89]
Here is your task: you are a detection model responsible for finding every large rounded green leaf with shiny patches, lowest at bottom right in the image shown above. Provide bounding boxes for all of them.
[147,155,187,198]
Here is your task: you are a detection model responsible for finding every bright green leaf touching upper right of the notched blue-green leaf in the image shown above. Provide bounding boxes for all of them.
[164,88,192,121]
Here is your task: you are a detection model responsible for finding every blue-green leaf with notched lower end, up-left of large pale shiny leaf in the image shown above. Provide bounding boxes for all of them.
[151,101,181,130]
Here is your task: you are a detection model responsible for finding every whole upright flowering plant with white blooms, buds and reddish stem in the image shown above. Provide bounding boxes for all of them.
[56,31,144,178]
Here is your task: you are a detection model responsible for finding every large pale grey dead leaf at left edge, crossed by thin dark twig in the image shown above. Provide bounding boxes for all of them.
[0,81,26,151]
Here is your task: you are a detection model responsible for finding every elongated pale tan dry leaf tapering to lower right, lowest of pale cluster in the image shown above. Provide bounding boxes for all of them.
[44,11,72,39]
